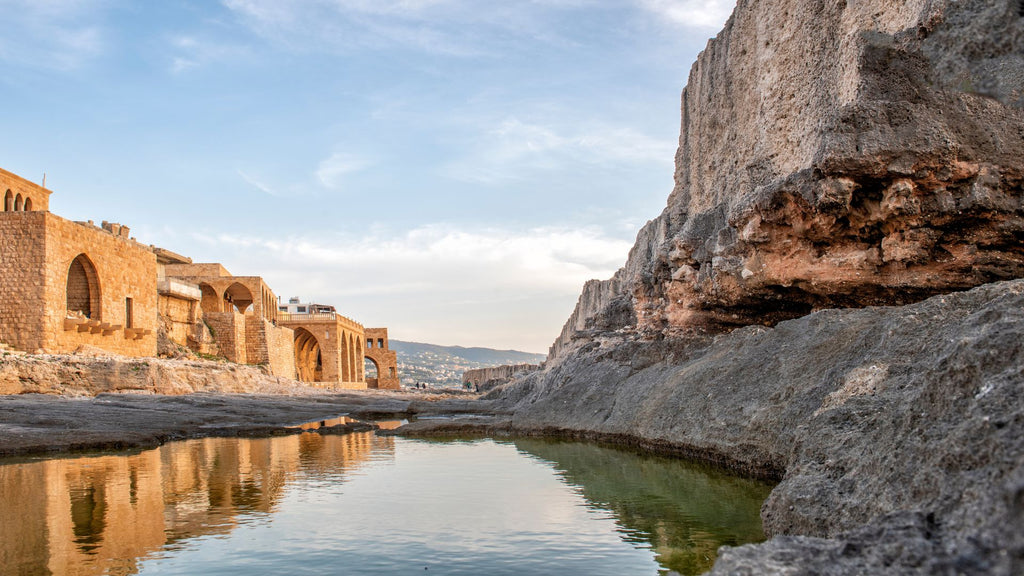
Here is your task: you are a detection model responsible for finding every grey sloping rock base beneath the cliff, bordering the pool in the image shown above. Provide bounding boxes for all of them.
[493,281,1024,574]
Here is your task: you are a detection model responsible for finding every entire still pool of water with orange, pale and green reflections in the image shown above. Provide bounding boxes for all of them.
[0,433,770,576]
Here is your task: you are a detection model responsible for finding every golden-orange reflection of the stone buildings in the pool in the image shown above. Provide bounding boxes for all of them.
[0,434,394,576]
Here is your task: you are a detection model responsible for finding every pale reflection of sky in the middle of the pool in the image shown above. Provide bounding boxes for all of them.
[140,439,657,575]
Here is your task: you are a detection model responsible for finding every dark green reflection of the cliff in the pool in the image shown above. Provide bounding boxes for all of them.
[515,440,770,574]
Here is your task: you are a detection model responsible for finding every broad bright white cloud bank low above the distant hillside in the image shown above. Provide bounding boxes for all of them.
[182,220,632,351]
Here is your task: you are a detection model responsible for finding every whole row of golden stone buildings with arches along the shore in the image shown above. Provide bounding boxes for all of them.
[0,166,397,387]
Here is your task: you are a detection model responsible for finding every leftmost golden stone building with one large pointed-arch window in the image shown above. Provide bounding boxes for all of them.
[0,166,157,357]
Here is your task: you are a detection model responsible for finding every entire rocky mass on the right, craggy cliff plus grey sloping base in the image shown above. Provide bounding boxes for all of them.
[492,0,1024,574]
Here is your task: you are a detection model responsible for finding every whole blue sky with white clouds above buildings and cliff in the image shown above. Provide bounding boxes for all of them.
[0,0,734,353]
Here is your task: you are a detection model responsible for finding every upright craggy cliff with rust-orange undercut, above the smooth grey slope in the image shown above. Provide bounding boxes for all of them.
[552,0,1024,354]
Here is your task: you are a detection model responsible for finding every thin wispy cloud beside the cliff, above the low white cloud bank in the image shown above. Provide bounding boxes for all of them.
[443,118,676,183]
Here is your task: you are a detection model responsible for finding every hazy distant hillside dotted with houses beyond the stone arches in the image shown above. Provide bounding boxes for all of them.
[390,340,546,386]
